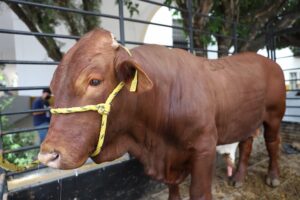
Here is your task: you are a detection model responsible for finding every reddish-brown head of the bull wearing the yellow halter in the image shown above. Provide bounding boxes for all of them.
[39,29,152,169]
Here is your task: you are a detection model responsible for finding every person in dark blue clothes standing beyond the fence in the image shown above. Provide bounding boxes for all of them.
[32,88,51,143]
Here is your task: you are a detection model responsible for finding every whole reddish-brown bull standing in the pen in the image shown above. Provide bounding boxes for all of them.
[39,29,285,200]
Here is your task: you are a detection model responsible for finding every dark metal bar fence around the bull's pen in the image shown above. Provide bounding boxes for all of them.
[0,0,296,197]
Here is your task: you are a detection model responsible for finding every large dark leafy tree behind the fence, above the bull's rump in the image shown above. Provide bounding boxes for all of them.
[165,0,300,56]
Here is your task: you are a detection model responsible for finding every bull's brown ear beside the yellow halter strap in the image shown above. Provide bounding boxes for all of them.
[116,60,153,92]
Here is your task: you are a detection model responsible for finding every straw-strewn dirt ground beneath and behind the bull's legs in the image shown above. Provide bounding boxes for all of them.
[143,136,300,200]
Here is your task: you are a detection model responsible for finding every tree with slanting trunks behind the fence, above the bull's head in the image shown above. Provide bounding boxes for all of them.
[6,0,139,61]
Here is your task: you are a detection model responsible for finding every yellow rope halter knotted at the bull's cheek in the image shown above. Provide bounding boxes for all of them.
[50,46,137,157]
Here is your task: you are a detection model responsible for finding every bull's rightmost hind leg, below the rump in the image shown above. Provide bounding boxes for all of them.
[264,117,281,187]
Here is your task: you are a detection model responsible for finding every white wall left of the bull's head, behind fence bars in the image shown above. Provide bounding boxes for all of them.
[0,3,55,96]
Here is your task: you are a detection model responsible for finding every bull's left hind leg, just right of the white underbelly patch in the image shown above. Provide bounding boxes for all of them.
[231,137,253,187]
